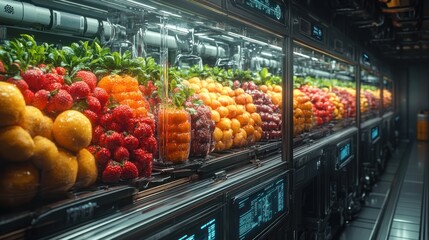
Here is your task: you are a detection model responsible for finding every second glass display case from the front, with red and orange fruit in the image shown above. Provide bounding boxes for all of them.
[293,42,356,144]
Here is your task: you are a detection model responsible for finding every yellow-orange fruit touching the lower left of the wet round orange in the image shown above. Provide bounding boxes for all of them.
[31,136,58,171]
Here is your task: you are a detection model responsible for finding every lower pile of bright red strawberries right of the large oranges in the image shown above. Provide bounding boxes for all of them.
[88,101,158,183]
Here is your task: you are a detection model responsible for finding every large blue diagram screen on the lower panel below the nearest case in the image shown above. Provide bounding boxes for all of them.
[233,179,287,239]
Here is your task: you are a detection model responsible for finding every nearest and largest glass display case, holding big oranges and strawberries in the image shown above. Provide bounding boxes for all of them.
[0,0,286,235]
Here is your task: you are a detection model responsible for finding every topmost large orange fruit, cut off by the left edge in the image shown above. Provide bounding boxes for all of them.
[0,81,25,127]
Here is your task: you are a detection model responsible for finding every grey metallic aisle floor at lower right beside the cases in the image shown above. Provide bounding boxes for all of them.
[339,142,429,240]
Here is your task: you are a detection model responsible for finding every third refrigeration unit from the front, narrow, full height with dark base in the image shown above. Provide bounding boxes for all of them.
[359,52,385,192]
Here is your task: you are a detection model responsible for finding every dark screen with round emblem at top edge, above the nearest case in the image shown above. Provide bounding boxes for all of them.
[239,0,285,23]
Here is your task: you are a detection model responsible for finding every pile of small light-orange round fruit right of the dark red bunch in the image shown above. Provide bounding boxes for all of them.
[184,77,262,151]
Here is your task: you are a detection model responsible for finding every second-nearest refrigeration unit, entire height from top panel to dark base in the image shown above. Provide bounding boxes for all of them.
[292,6,358,239]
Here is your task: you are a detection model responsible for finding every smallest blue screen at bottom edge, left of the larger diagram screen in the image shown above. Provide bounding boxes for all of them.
[175,217,221,240]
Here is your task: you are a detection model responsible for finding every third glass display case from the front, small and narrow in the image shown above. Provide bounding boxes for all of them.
[360,68,381,123]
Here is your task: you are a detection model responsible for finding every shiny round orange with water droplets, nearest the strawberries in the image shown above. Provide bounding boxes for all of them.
[52,110,92,152]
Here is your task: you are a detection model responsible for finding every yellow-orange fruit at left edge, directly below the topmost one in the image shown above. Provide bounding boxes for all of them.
[0,126,34,161]
